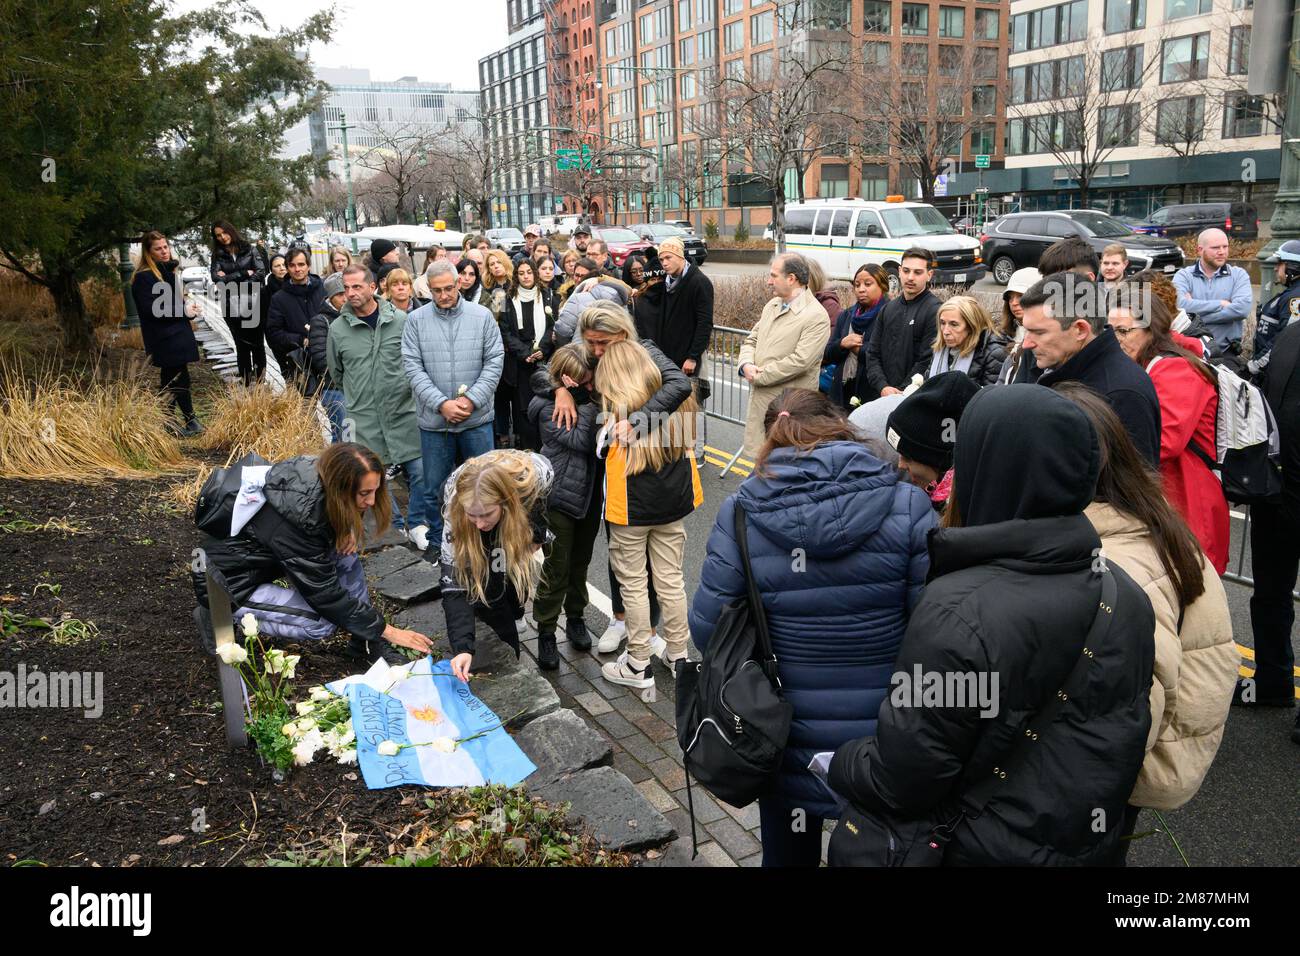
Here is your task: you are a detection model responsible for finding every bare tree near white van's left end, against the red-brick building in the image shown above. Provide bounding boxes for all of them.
[690,27,850,252]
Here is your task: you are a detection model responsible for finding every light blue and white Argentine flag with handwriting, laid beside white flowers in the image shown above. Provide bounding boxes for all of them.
[326,657,537,790]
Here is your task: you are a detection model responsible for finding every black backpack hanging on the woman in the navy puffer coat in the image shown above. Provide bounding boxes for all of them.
[677,502,794,840]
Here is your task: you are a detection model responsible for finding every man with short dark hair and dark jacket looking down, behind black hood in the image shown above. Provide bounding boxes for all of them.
[1021,272,1160,468]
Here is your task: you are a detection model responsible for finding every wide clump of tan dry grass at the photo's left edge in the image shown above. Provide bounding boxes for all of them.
[0,359,182,481]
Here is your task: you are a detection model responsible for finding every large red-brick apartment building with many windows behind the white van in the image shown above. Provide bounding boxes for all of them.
[595,0,1008,232]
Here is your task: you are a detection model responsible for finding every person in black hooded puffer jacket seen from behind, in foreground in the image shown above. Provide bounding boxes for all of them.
[828,385,1156,866]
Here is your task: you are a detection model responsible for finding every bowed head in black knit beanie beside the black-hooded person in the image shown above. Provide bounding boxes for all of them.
[885,372,979,511]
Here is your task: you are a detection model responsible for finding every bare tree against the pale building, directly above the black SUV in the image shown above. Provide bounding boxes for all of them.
[1009,30,1161,206]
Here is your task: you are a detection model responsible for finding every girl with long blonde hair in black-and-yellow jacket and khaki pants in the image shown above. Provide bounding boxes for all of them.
[595,338,705,688]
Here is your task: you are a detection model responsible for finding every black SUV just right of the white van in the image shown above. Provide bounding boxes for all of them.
[980,209,1183,285]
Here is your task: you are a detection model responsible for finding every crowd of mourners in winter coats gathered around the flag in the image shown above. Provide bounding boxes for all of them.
[126,217,1300,865]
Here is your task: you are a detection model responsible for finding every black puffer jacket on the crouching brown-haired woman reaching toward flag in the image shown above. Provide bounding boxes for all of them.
[192,455,385,640]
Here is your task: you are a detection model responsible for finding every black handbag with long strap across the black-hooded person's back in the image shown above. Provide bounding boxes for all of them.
[827,570,1115,866]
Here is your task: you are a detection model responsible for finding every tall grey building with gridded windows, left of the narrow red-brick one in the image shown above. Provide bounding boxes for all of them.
[478,0,559,229]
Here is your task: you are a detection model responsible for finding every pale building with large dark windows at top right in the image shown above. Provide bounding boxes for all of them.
[954,0,1284,220]
